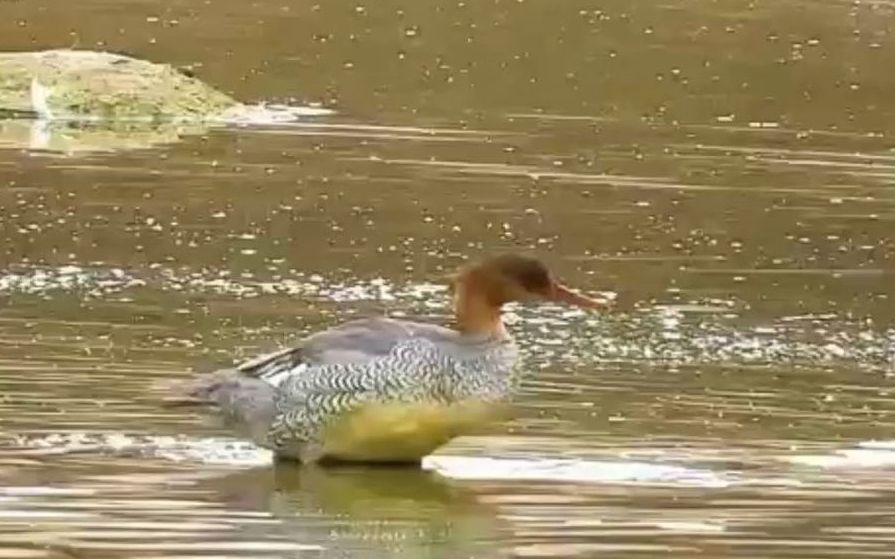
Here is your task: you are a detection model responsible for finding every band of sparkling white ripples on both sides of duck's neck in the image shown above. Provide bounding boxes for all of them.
[0,266,895,371]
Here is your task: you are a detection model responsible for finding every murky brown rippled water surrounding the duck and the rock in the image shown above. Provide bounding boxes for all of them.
[0,0,895,559]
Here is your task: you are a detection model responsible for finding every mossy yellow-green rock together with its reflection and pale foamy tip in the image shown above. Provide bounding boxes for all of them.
[0,49,332,155]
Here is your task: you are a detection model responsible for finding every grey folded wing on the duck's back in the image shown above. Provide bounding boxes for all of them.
[237,317,457,384]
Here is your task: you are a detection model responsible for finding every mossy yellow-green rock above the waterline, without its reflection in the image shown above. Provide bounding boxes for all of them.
[0,49,243,121]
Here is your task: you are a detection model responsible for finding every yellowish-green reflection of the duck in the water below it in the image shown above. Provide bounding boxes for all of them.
[200,461,506,558]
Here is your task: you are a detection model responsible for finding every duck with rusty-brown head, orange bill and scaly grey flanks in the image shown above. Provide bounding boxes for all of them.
[169,253,610,464]
